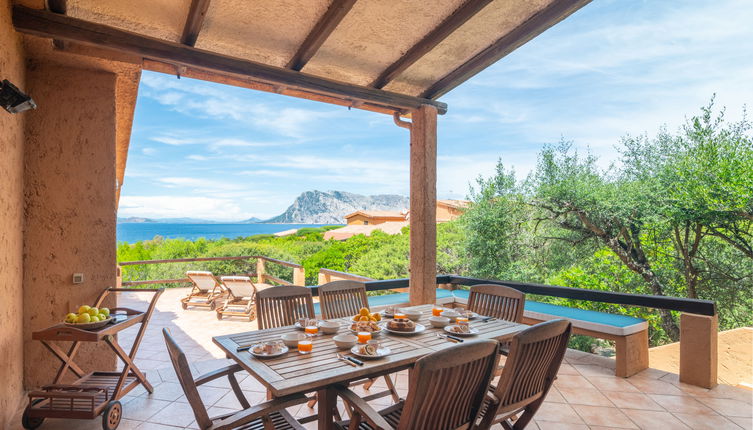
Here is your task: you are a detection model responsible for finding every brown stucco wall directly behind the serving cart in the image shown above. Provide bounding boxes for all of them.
[24,60,116,388]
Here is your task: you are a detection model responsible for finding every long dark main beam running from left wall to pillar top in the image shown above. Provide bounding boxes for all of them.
[13,6,447,114]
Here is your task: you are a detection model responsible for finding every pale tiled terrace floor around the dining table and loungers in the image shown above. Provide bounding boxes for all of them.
[42,288,753,430]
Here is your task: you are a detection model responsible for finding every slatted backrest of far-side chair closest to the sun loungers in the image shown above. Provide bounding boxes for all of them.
[256,286,314,329]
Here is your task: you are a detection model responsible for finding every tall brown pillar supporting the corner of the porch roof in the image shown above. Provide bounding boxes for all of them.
[410,105,437,305]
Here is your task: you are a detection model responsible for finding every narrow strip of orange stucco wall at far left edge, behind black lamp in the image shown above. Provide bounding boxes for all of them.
[0,0,26,429]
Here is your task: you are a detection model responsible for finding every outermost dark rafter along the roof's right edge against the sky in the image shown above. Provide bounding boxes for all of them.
[421,0,591,100]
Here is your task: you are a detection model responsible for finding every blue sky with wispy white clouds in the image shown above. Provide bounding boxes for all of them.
[118,0,753,221]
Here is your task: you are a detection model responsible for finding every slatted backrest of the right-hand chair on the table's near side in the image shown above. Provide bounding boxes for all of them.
[494,319,572,415]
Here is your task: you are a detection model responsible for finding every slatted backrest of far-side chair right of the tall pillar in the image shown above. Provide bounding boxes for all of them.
[468,284,526,322]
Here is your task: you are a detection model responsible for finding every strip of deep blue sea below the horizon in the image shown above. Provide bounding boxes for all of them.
[117,222,332,243]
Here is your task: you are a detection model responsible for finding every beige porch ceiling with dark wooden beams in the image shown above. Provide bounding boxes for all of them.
[13,0,589,113]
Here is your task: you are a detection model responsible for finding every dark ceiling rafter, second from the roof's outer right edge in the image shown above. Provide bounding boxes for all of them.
[371,0,492,88]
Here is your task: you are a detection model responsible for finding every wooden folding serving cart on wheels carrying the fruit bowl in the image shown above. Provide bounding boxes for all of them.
[22,288,164,430]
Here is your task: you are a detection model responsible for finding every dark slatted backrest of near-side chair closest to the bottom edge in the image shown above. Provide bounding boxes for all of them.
[397,340,499,430]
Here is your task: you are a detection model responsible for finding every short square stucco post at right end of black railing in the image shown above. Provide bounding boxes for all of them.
[680,313,719,388]
